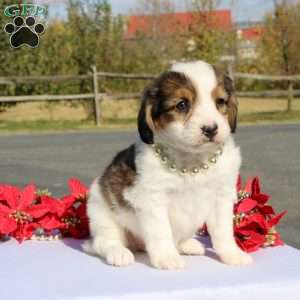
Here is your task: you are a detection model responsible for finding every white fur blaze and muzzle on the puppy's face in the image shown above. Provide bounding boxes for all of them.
[155,61,230,153]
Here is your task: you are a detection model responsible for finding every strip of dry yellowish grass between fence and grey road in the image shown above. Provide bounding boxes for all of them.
[0,98,300,133]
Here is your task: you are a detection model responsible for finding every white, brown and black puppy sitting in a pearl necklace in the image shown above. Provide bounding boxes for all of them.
[84,61,252,269]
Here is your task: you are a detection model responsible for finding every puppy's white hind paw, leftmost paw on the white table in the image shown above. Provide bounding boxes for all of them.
[105,246,134,267]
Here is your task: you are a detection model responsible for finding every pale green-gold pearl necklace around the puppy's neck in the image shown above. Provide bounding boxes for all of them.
[152,144,223,175]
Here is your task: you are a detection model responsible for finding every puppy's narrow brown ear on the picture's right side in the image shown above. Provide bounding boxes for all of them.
[223,74,238,133]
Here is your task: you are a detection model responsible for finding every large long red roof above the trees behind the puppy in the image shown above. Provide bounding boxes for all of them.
[125,10,233,39]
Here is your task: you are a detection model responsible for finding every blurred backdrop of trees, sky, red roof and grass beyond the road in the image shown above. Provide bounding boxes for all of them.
[0,0,300,131]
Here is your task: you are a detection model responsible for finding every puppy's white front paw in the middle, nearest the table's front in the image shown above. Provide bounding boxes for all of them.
[150,251,185,270]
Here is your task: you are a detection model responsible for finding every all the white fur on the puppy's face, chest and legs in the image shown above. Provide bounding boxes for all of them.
[86,62,252,269]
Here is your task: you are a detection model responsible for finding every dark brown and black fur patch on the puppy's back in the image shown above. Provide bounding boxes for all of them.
[100,145,136,209]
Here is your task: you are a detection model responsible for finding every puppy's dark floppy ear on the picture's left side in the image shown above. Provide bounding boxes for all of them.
[138,86,157,144]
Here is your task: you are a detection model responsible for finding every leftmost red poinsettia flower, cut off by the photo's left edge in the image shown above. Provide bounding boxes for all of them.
[0,184,48,241]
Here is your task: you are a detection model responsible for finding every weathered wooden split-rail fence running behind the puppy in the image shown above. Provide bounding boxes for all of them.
[0,66,300,126]
